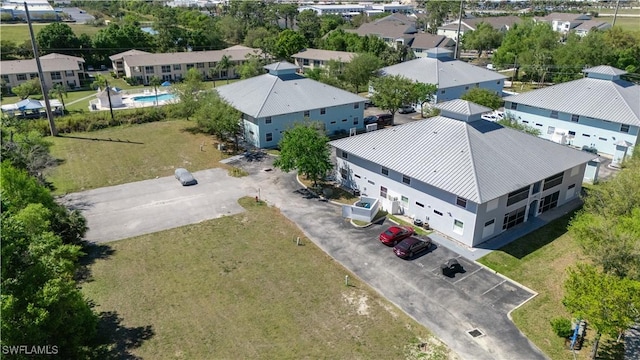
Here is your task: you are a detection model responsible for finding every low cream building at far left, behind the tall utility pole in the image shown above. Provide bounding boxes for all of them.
[0,53,85,91]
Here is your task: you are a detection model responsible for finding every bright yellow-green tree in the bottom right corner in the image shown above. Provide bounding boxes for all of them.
[562,264,640,359]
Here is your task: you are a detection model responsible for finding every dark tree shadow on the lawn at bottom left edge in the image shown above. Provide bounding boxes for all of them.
[91,311,155,360]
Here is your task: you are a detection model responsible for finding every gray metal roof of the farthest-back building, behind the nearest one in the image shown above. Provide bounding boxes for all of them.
[381,57,507,89]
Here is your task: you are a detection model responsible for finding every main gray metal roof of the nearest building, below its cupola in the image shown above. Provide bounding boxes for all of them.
[330,116,594,203]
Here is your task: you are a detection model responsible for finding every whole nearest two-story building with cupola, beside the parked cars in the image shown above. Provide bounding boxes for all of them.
[330,100,593,247]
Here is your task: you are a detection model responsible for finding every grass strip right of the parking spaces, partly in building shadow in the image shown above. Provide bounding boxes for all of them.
[479,213,614,360]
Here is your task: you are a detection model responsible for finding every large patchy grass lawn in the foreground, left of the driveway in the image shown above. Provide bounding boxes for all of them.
[82,198,448,359]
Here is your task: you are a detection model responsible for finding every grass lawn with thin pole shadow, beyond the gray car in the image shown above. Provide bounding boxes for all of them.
[48,120,223,194]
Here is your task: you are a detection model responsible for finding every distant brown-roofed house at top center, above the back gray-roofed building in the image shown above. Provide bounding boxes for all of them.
[351,14,418,48]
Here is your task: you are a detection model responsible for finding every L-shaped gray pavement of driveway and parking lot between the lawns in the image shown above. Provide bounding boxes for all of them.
[64,155,546,360]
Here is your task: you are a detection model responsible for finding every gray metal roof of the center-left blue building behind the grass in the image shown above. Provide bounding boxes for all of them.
[216,74,366,118]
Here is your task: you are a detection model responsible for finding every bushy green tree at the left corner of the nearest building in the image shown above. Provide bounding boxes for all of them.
[273,121,333,186]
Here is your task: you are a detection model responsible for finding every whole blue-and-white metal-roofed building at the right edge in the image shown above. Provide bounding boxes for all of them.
[504,65,640,165]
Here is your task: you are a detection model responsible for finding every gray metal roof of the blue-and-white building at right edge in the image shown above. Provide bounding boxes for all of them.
[504,78,640,126]
